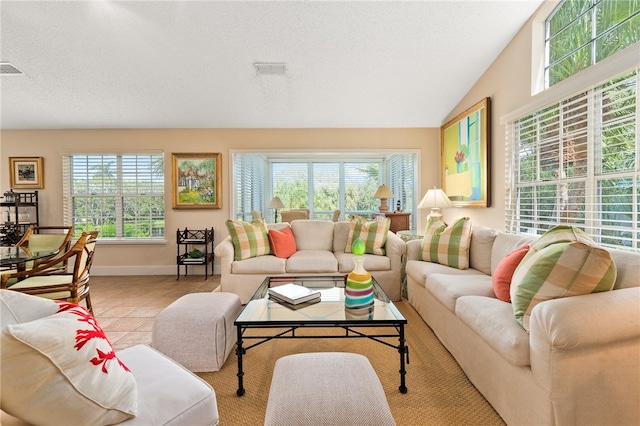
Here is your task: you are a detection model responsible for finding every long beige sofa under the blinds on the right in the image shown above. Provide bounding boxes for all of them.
[406,226,640,425]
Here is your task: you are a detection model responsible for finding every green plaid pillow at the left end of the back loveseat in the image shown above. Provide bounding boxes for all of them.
[225,220,271,260]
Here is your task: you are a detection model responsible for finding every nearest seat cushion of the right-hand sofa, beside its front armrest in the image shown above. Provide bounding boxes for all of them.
[456,296,531,368]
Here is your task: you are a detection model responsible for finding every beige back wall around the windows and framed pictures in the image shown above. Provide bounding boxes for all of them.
[0,128,439,275]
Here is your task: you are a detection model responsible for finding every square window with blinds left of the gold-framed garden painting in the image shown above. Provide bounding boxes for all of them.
[63,153,165,239]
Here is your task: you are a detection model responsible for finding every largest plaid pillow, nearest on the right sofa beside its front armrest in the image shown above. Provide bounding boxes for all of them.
[511,225,616,331]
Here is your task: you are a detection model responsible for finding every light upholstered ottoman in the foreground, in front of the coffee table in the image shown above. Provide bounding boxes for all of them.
[264,352,396,426]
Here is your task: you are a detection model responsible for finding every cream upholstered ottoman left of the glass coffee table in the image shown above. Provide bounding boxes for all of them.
[151,292,242,372]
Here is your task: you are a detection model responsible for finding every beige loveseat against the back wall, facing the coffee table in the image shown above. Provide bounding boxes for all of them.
[214,220,406,304]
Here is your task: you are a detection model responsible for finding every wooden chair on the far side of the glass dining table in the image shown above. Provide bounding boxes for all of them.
[16,226,74,273]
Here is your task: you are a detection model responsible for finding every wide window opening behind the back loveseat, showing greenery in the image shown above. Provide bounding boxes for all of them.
[234,152,417,226]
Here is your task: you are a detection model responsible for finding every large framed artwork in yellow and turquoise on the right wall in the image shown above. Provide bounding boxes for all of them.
[440,98,491,207]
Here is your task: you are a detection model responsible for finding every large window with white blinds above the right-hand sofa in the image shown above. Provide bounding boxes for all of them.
[505,68,640,251]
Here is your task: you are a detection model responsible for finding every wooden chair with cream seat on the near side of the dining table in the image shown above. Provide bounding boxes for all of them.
[0,231,98,313]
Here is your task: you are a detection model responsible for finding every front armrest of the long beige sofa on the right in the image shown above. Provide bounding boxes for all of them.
[529,287,640,424]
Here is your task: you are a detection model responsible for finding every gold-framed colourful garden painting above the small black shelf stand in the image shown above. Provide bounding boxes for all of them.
[171,153,222,209]
